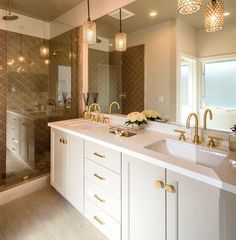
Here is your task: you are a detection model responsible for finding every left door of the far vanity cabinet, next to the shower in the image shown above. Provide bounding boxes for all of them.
[51,129,68,197]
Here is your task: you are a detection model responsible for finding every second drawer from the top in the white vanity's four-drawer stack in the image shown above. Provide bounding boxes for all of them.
[85,159,121,198]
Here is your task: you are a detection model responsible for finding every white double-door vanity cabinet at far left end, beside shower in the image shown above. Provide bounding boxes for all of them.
[51,129,84,213]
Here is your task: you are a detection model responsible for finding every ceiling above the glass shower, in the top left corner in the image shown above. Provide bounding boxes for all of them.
[0,0,83,21]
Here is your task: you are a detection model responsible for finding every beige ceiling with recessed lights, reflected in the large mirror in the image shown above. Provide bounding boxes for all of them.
[96,0,236,37]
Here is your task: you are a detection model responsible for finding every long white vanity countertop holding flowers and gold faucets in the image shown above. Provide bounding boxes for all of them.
[48,119,236,194]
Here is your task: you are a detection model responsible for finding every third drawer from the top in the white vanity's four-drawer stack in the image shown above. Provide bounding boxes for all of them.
[85,178,121,222]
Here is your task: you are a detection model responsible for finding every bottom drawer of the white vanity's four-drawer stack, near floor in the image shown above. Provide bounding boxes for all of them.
[84,198,121,240]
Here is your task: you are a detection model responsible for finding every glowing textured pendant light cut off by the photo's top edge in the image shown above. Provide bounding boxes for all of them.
[178,0,202,15]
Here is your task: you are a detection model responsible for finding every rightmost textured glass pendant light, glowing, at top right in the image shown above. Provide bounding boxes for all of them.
[205,0,224,32]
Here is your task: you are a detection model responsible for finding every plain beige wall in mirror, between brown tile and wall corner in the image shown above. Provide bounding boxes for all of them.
[128,20,176,119]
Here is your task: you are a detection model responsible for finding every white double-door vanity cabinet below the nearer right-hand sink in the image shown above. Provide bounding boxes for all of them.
[122,155,220,240]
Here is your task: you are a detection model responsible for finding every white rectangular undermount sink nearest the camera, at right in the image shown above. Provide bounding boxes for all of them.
[145,139,227,168]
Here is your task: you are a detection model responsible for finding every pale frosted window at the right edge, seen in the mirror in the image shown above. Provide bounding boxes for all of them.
[202,59,236,109]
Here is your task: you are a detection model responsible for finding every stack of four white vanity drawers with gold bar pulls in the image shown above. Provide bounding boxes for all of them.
[84,141,121,240]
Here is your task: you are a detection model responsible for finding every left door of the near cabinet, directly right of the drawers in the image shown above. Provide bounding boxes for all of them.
[122,155,165,240]
